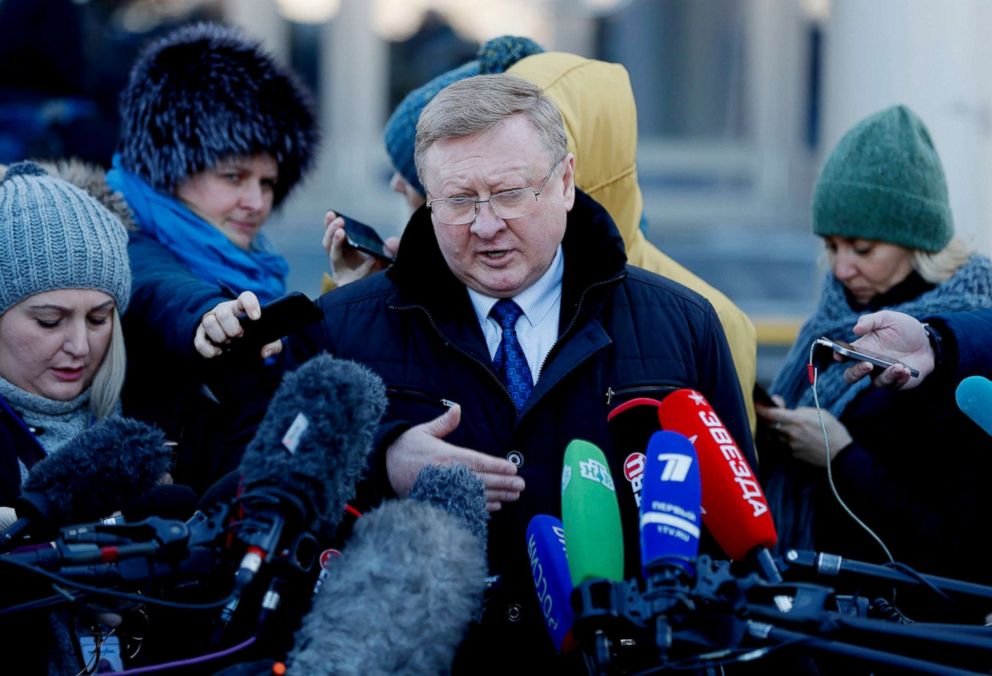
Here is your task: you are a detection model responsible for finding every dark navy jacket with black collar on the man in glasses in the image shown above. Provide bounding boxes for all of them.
[295,192,754,673]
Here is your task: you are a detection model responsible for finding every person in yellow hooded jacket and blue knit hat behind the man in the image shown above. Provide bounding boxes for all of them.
[324,36,757,433]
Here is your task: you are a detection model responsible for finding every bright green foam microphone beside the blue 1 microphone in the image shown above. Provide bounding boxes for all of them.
[561,439,623,586]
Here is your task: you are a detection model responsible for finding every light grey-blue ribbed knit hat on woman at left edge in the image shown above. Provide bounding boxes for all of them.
[0,162,131,314]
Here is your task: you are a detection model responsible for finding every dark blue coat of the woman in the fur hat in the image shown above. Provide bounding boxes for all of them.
[121,232,284,493]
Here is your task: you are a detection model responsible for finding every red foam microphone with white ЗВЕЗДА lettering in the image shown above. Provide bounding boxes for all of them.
[658,389,782,582]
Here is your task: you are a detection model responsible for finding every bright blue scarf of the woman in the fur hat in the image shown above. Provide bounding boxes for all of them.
[107,155,289,305]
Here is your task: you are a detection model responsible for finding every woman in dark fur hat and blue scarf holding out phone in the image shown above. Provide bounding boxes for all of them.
[107,24,318,489]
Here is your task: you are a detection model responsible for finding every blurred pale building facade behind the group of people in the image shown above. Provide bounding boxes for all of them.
[0,0,992,379]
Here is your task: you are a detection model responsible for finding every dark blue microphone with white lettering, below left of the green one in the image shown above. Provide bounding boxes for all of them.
[527,514,576,654]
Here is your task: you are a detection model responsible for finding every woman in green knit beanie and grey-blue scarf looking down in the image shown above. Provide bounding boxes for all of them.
[759,106,992,588]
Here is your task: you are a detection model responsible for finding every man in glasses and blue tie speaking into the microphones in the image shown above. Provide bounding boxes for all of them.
[294,75,754,673]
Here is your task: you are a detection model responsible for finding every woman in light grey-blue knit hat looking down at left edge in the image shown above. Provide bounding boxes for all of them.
[0,162,131,505]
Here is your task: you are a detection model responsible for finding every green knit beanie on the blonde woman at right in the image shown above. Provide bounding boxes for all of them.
[813,106,954,252]
